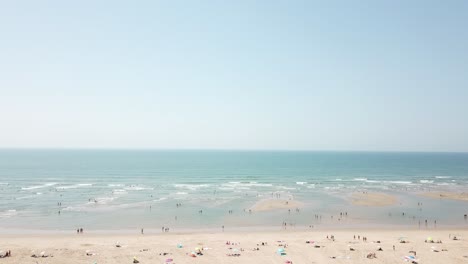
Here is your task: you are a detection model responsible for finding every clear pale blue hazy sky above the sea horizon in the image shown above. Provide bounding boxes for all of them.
[0,0,468,152]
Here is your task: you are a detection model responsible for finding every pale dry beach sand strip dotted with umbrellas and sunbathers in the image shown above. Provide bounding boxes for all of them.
[0,230,468,264]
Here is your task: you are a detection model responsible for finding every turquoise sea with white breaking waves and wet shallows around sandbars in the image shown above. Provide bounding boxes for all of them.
[0,150,468,230]
